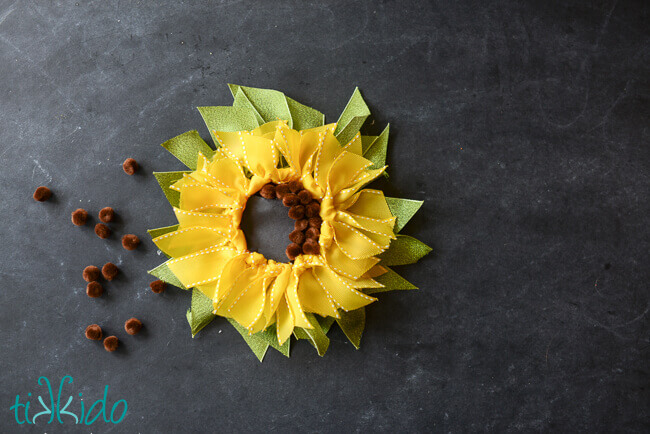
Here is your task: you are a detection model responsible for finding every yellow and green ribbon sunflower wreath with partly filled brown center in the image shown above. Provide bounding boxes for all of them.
[149,85,431,361]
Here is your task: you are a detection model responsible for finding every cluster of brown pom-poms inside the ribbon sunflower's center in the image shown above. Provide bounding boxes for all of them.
[260,181,323,261]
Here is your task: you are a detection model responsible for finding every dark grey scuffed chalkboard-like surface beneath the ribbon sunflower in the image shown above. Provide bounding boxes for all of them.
[0,0,650,433]
